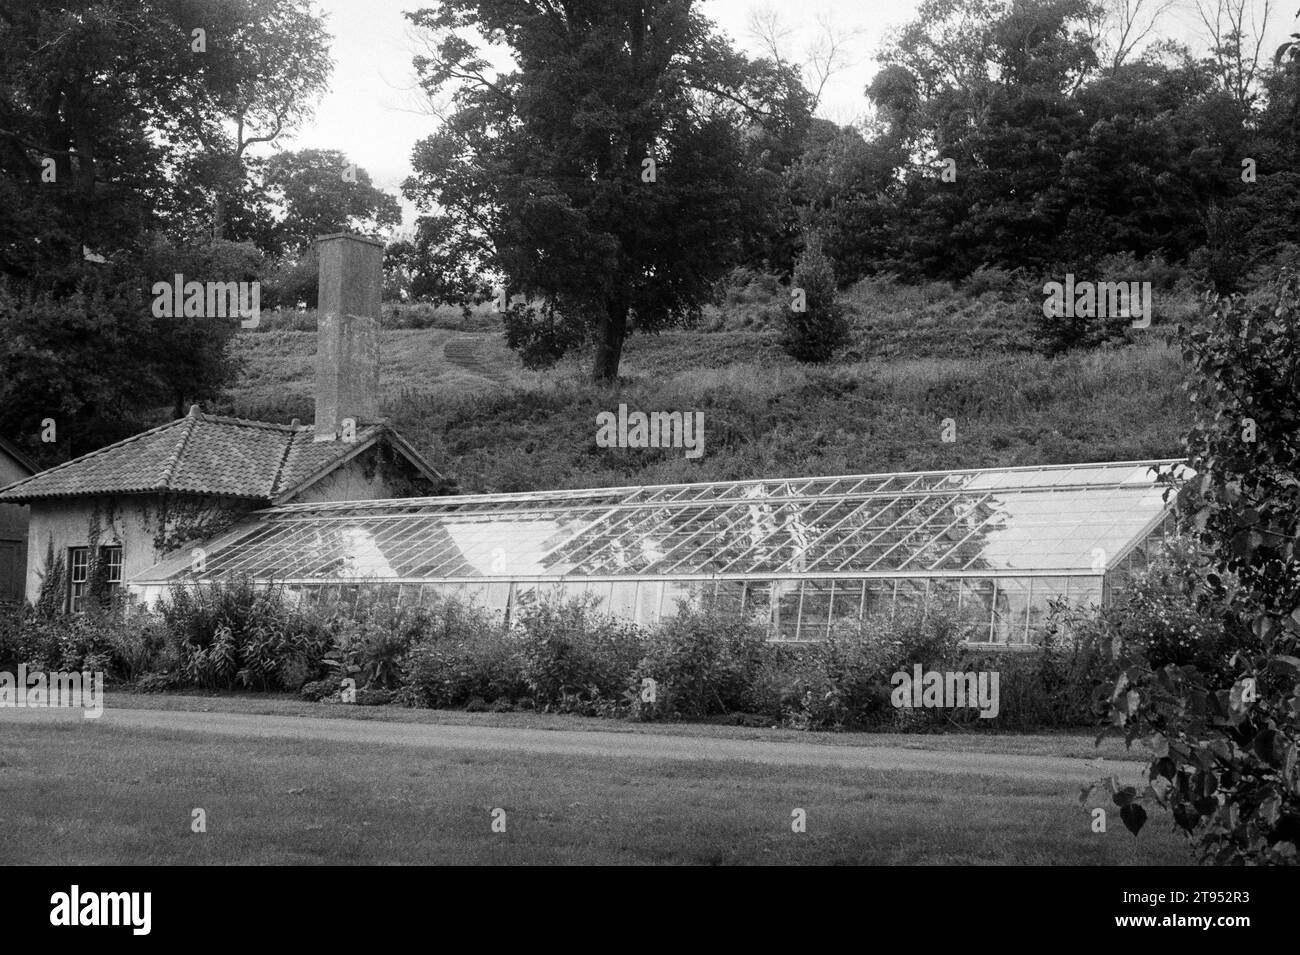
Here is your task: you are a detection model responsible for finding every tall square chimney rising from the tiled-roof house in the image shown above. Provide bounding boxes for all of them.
[313,233,384,440]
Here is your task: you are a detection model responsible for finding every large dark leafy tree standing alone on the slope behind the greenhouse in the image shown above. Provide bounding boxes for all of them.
[403,0,810,381]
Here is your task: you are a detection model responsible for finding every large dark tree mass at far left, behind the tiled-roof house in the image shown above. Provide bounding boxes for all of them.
[0,0,325,463]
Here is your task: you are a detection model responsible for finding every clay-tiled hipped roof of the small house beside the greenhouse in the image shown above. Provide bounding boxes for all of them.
[0,411,437,502]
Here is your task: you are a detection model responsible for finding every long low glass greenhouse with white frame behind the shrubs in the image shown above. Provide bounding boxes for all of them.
[131,461,1187,646]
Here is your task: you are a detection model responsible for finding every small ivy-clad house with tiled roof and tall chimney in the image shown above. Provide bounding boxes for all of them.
[0,235,446,612]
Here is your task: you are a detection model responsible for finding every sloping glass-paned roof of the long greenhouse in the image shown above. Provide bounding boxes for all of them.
[133,461,1187,583]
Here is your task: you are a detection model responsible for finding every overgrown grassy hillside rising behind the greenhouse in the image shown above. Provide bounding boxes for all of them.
[215,283,1193,491]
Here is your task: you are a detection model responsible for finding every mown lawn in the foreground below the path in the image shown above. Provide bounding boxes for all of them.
[0,721,1190,865]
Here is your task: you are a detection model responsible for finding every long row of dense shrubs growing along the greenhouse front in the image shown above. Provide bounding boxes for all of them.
[0,582,1133,730]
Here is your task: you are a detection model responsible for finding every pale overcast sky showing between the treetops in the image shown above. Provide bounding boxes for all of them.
[282,0,1295,227]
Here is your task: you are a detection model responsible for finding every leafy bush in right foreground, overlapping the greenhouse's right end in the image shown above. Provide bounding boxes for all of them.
[1109,272,1300,864]
